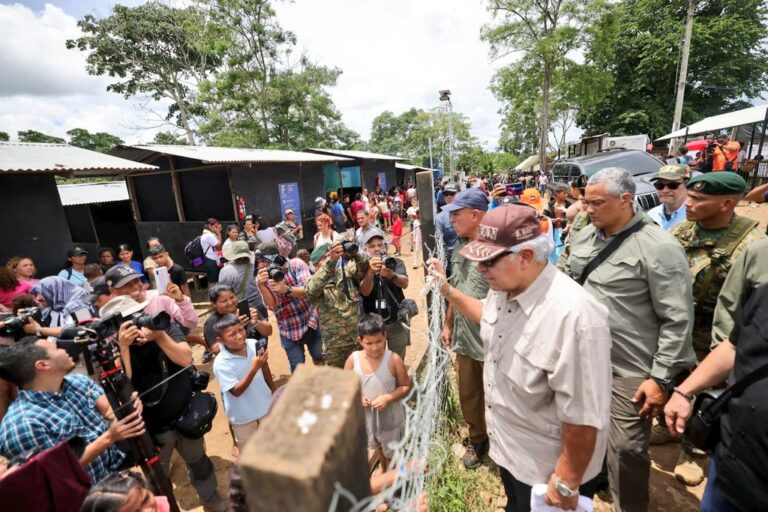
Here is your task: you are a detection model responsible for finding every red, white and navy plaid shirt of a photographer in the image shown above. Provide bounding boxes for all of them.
[272,258,319,341]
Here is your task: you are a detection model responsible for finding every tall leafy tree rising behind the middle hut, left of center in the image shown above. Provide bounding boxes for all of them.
[195,0,359,149]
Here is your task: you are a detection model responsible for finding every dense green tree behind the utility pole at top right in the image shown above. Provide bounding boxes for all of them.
[577,0,768,136]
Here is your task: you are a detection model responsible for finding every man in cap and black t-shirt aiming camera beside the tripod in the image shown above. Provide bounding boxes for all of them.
[100,267,225,510]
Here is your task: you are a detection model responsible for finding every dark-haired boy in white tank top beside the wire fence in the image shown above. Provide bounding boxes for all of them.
[344,313,411,471]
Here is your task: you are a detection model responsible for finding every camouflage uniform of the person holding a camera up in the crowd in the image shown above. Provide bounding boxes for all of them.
[304,254,369,368]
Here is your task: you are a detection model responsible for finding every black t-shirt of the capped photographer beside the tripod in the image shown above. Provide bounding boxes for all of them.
[130,323,192,433]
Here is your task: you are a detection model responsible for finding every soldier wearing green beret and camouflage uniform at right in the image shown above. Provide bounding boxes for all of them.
[664,172,765,485]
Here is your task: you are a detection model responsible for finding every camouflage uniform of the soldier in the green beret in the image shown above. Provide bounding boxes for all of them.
[671,215,765,362]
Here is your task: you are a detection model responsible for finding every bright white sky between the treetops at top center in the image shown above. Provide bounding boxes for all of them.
[276,0,500,147]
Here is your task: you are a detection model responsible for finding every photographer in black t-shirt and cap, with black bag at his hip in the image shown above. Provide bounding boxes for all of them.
[100,290,225,510]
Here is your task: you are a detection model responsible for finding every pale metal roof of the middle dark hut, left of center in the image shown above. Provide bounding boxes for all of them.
[112,144,348,164]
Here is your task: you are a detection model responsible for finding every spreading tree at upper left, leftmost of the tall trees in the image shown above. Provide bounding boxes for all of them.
[66,1,216,144]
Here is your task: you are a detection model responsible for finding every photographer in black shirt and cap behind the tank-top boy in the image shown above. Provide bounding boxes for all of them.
[360,231,411,360]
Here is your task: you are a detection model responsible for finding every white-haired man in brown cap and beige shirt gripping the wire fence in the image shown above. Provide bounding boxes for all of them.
[429,204,611,512]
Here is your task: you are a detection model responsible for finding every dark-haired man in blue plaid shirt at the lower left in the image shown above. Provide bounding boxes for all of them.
[0,336,145,482]
